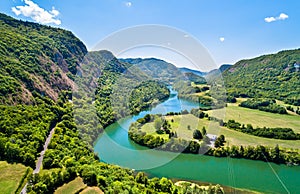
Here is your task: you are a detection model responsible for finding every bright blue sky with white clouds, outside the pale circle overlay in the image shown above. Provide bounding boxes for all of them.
[0,0,300,69]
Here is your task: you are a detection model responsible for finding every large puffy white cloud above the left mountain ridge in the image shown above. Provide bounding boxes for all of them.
[11,0,61,25]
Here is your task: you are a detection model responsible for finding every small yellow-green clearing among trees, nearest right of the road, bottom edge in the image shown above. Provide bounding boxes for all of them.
[54,177,86,194]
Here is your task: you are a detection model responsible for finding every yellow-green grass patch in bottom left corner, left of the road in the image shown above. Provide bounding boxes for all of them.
[0,161,28,194]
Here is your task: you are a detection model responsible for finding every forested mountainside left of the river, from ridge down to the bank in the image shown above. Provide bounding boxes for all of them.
[0,14,179,193]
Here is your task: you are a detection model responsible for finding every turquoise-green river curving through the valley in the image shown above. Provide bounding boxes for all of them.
[94,90,300,193]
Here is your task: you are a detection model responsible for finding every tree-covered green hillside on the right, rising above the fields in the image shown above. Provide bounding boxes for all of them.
[223,49,300,106]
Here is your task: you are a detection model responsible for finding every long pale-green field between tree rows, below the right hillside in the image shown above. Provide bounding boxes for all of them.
[207,103,300,133]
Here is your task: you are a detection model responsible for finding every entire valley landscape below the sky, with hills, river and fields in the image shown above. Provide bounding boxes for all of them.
[0,14,300,194]
